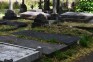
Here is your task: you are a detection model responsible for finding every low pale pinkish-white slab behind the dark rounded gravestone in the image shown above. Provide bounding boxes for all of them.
[20,11,50,19]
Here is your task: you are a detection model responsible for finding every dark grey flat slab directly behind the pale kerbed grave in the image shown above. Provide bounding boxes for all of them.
[0,36,67,54]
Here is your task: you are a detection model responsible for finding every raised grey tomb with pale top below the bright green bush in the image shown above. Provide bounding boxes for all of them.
[59,12,93,22]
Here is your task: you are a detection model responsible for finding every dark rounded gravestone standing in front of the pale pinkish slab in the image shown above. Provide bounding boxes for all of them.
[32,14,48,27]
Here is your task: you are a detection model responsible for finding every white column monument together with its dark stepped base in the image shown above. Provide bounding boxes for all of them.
[3,0,17,19]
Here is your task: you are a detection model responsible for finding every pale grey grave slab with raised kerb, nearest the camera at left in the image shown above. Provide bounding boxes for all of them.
[0,42,40,62]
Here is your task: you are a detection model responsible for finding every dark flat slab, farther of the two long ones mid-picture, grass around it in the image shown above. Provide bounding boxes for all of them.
[14,30,80,45]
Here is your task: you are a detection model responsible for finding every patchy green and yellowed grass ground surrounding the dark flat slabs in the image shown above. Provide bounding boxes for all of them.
[0,15,93,62]
